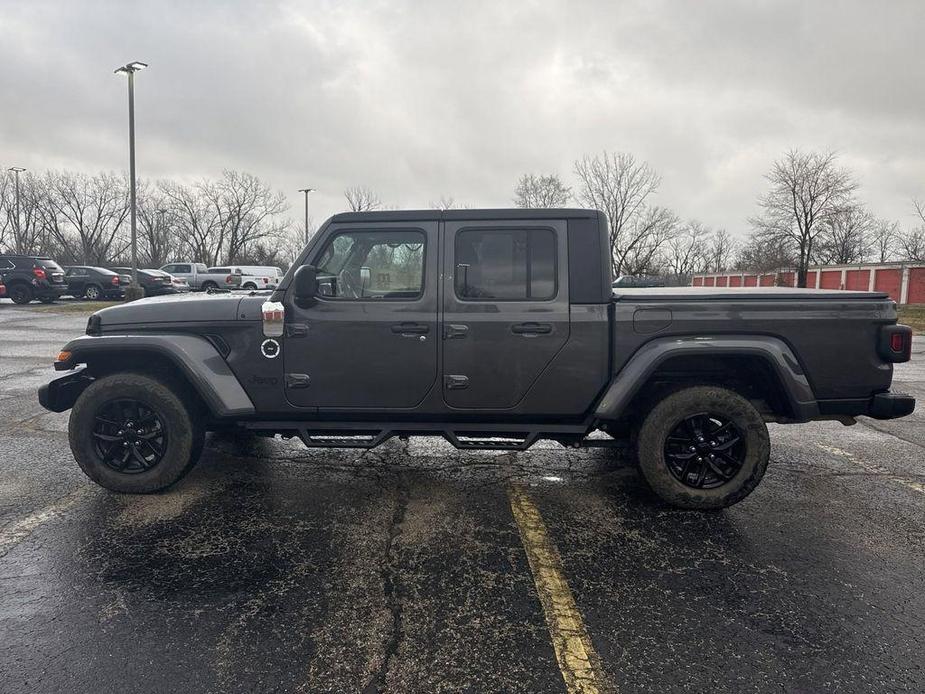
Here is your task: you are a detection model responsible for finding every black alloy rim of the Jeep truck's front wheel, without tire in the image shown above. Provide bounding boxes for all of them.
[93,399,167,474]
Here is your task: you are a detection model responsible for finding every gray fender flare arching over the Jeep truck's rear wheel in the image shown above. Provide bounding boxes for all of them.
[594,335,819,421]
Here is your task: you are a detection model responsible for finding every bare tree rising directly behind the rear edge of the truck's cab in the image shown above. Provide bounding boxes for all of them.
[575,152,678,275]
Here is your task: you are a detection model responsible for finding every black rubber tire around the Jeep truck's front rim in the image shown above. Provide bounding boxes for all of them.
[68,372,205,494]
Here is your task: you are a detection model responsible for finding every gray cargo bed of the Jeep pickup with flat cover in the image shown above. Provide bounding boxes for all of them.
[612,287,896,411]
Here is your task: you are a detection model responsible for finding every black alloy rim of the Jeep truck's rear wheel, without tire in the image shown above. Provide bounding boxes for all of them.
[664,412,748,489]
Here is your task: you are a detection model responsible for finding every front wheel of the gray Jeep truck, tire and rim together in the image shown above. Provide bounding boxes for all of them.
[68,373,204,493]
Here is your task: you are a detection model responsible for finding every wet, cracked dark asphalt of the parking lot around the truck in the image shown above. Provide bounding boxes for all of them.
[0,302,925,692]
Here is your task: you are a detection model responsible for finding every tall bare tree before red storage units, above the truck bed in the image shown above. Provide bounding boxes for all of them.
[750,150,857,287]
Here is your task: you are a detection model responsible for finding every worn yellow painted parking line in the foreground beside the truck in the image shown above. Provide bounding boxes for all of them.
[508,486,613,694]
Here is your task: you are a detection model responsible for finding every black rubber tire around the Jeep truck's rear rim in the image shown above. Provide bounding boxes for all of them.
[637,386,771,510]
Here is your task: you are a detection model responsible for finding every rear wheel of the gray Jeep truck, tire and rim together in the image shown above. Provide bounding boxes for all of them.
[638,386,770,509]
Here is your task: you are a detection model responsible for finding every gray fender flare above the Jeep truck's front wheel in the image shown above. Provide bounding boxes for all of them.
[54,334,254,417]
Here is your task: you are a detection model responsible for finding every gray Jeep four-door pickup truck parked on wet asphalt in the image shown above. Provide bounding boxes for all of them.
[39,209,915,509]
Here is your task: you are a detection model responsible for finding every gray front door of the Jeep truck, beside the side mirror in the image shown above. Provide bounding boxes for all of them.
[283,222,439,410]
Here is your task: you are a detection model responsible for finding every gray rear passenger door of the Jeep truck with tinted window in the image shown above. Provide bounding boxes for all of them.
[443,220,569,410]
